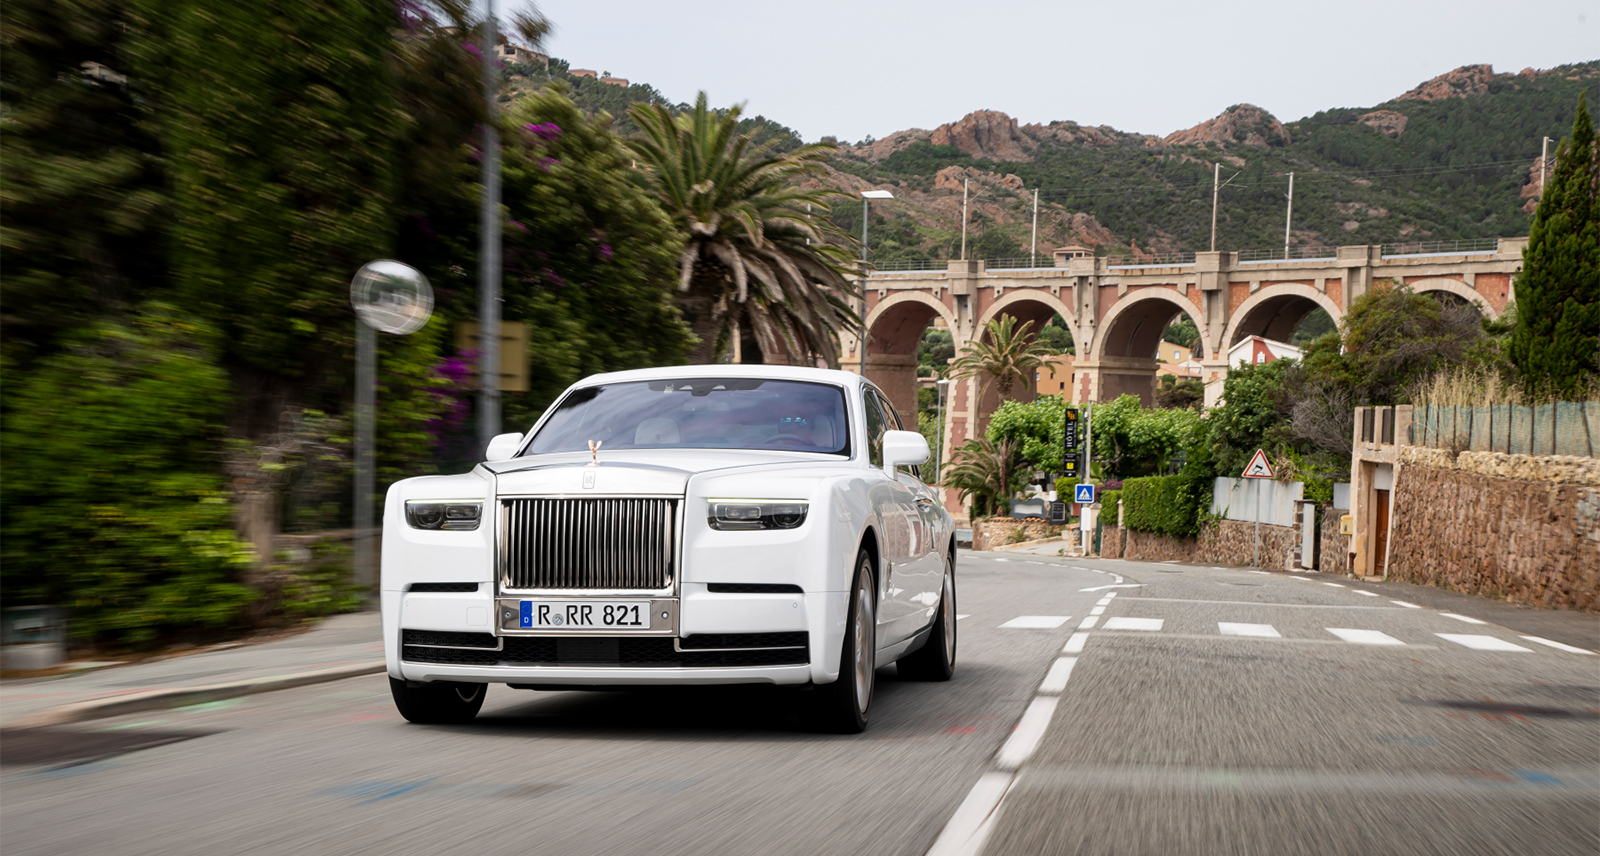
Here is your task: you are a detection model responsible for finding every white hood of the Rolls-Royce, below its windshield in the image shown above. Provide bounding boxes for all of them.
[480,450,848,496]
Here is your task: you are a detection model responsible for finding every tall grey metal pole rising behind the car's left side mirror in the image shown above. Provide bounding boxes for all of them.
[478,0,501,450]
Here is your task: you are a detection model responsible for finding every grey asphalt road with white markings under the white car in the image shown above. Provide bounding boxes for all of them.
[0,554,1600,856]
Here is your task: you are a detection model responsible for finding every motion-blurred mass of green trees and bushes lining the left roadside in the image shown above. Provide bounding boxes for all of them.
[0,0,690,646]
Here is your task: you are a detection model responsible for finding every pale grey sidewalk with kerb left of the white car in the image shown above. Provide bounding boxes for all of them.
[0,611,384,726]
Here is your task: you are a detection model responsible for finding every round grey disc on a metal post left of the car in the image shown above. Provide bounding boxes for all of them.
[350,259,434,602]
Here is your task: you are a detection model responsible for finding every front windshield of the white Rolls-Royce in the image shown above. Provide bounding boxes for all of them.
[525,378,850,454]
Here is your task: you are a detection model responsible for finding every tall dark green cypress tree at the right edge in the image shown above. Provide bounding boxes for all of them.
[1510,96,1600,398]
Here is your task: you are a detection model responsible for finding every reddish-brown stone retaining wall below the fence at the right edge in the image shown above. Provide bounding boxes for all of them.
[1387,467,1600,611]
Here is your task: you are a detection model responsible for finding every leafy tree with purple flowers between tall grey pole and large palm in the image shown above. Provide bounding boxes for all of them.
[504,90,691,427]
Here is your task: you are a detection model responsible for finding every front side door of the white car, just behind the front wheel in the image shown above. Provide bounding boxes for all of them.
[861,387,922,648]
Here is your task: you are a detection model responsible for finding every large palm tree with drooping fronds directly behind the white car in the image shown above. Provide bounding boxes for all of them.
[629,93,858,366]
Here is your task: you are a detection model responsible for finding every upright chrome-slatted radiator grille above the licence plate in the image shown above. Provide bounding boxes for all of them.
[501,498,678,592]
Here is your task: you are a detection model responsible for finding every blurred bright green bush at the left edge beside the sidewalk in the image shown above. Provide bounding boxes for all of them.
[0,304,253,645]
